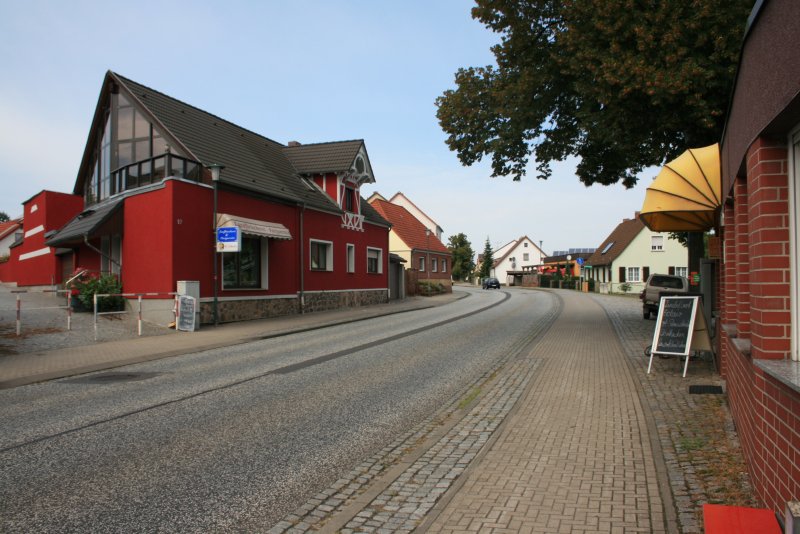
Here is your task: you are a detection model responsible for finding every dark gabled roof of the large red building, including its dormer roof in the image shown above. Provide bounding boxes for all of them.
[74,71,384,223]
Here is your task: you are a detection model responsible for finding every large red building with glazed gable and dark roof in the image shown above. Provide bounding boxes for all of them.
[4,72,390,322]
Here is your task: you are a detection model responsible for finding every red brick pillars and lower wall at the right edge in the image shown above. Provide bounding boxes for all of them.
[720,138,800,513]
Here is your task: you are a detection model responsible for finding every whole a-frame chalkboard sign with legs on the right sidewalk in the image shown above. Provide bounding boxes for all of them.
[647,297,711,377]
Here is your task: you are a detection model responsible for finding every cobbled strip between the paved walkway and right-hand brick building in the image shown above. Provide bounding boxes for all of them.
[592,295,759,534]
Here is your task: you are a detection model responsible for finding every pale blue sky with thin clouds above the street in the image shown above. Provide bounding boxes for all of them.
[0,0,658,254]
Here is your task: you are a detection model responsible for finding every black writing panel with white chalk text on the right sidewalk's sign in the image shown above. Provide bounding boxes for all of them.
[653,297,698,356]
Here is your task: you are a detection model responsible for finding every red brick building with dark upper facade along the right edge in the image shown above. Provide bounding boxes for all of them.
[720,0,800,525]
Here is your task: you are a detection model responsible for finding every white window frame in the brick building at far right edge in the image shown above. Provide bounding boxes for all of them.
[788,125,800,362]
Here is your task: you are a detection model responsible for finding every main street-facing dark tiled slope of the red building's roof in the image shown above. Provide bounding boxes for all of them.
[109,73,352,217]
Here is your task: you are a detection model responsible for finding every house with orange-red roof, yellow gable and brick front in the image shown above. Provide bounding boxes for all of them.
[369,199,453,292]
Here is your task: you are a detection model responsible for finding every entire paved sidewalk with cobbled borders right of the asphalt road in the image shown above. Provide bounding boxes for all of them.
[270,291,755,534]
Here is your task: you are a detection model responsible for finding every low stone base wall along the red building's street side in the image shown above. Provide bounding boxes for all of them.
[200,289,389,324]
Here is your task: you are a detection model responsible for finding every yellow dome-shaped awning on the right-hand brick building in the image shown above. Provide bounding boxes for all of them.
[639,144,722,232]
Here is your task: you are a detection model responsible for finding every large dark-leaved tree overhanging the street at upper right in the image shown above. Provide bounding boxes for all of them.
[436,0,753,187]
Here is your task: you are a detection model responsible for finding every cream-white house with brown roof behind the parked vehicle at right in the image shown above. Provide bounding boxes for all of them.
[585,213,689,293]
